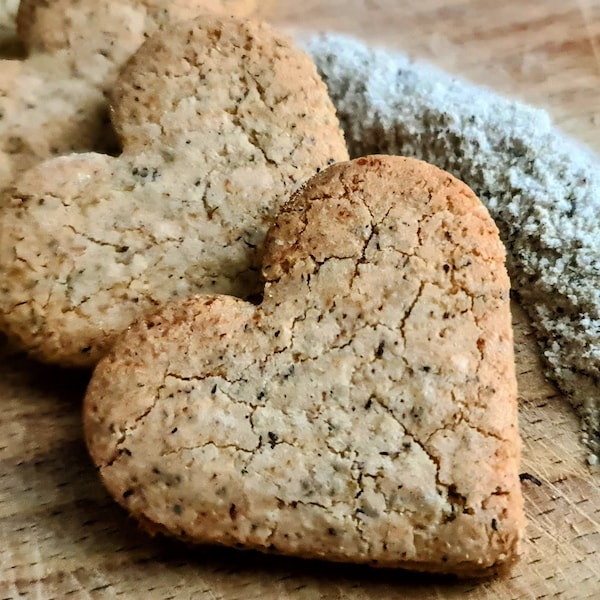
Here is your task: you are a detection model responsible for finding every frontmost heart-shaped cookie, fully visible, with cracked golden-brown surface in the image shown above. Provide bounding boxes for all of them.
[84,156,524,575]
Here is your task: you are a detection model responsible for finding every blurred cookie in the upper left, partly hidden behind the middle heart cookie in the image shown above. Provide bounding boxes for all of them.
[0,0,272,188]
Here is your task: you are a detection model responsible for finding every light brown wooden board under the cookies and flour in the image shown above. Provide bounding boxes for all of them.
[0,0,600,600]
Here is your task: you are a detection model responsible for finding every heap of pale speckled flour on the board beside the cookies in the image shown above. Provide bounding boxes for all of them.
[304,35,600,465]
